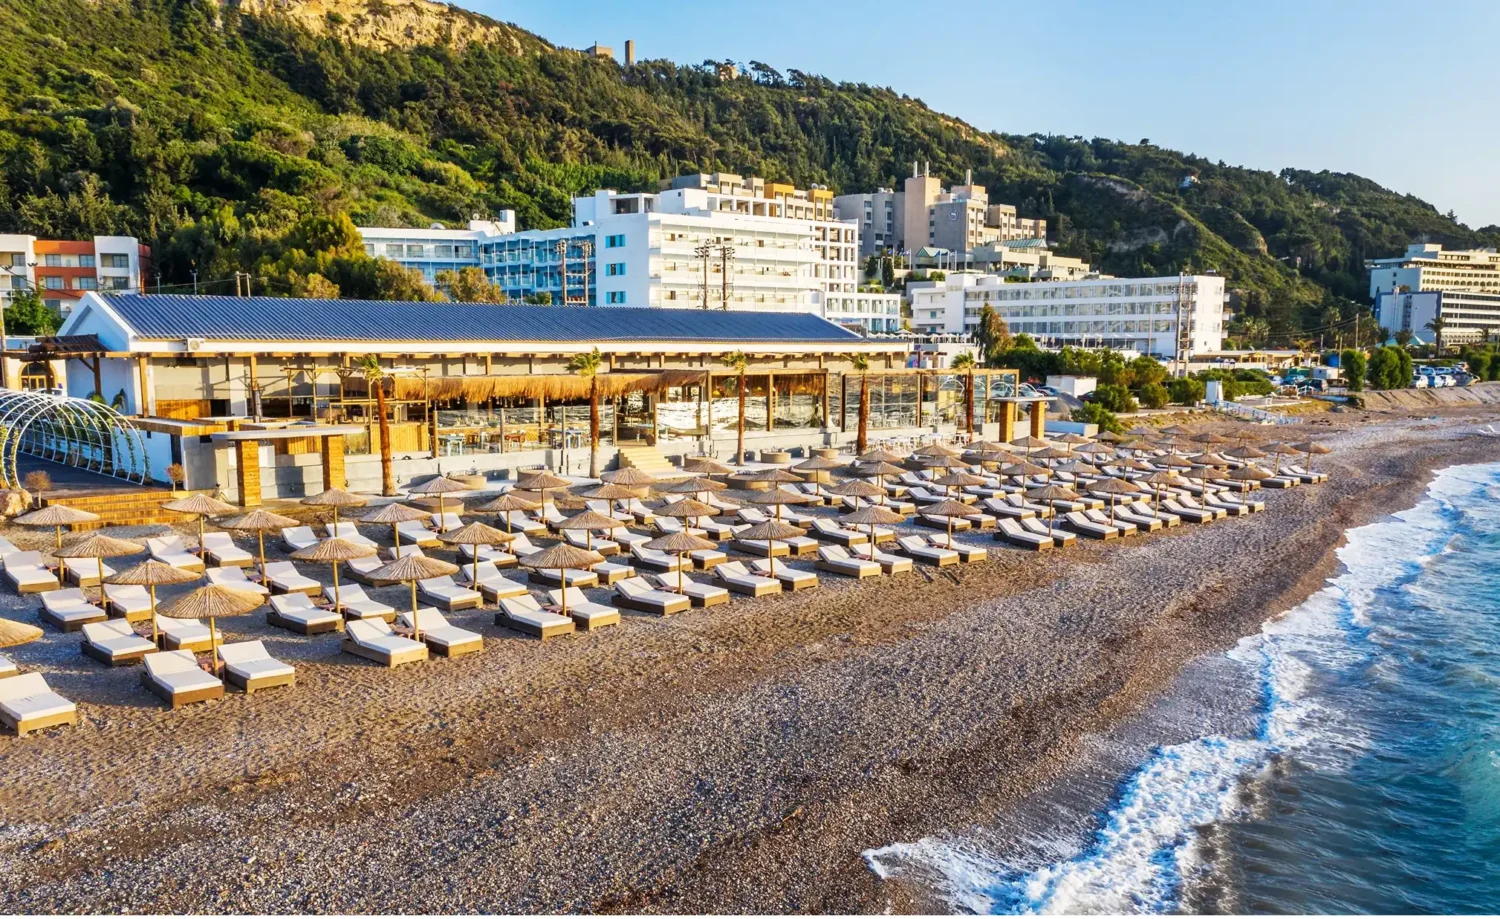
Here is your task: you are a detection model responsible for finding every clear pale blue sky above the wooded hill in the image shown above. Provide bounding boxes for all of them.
[459,0,1500,226]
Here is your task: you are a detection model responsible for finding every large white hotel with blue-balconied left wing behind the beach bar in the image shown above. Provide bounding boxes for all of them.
[360,174,902,331]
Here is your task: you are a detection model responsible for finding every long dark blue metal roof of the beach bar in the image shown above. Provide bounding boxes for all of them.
[96,294,863,343]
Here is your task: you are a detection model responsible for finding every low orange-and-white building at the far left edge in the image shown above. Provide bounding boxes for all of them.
[0,234,152,313]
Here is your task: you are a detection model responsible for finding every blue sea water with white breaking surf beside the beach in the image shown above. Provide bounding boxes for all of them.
[866,465,1500,913]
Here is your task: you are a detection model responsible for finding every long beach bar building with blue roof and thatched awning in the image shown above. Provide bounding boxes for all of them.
[17,294,1028,505]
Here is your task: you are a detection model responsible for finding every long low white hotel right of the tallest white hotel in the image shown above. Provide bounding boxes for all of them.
[908,271,1224,360]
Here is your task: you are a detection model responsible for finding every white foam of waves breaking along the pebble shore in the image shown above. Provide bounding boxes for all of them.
[864,471,1493,913]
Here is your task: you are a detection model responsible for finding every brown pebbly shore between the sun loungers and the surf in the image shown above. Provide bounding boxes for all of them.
[0,406,1500,913]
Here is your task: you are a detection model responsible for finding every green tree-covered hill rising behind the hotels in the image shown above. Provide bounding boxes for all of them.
[0,0,1500,340]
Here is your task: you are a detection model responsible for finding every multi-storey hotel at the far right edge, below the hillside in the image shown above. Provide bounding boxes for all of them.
[1367,243,1500,348]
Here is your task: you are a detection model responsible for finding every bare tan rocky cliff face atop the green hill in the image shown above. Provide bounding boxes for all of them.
[227,0,536,54]
